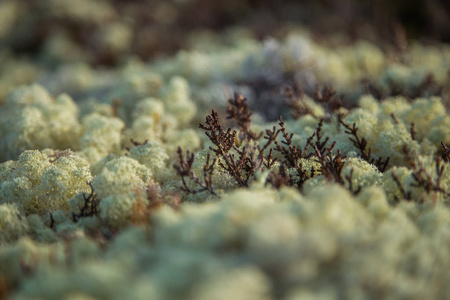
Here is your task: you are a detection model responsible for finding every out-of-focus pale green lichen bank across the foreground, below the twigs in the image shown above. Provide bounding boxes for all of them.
[0,185,450,299]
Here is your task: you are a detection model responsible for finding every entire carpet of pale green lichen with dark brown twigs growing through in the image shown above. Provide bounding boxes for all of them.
[0,11,450,300]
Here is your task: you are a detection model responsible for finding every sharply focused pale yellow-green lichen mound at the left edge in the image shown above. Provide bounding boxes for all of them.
[0,150,92,216]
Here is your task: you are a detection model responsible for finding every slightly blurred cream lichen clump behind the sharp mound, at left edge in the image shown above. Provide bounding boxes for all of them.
[0,84,81,159]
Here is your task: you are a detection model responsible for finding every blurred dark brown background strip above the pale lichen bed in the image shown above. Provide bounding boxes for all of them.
[0,0,450,68]
